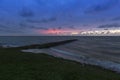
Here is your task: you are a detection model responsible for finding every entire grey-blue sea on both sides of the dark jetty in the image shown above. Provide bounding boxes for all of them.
[0,36,120,73]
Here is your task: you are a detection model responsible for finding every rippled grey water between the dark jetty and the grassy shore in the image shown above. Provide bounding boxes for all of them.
[18,37,120,73]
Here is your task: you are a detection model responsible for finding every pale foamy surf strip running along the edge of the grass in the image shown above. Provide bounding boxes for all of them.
[22,48,120,73]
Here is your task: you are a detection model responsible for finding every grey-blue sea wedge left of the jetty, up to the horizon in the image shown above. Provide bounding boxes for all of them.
[0,36,73,46]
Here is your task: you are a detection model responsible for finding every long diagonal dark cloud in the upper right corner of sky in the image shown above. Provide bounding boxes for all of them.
[85,0,119,14]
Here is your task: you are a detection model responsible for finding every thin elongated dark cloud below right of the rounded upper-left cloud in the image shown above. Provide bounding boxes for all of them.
[27,17,57,23]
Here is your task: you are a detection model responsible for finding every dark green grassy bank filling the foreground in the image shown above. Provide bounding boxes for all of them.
[0,39,120,80]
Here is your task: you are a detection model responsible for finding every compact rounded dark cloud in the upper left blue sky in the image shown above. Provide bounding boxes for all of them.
[20,7,35,17]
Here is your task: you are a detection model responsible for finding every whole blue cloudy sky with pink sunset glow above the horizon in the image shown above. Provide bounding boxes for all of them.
[0,0,120,36]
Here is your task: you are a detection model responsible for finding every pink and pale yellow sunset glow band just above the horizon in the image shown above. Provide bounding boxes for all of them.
[37,29,120,35]
